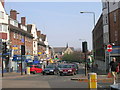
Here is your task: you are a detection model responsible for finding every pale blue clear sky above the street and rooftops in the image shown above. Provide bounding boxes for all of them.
[5,2,102,50]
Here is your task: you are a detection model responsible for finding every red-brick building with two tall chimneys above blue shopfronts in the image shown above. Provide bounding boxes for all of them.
[9,10,33,70]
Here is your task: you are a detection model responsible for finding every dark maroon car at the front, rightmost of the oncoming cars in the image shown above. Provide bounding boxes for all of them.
[59,64,76,76]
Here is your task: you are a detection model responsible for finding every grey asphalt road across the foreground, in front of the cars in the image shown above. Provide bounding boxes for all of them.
[2,66,110,88]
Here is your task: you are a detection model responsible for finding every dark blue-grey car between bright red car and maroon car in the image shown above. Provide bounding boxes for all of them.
[42,64,58,75]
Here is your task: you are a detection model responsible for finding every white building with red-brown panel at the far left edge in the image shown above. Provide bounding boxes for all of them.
[0,1,9,68]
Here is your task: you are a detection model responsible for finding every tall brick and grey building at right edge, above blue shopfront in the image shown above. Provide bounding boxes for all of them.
[93,0,120,71]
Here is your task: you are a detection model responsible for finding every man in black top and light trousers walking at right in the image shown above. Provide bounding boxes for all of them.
[110,58,118,84]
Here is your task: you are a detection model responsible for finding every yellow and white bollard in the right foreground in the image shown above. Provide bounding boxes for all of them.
[88,73,97,89]
